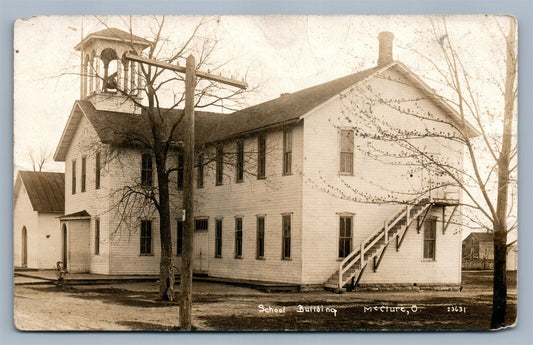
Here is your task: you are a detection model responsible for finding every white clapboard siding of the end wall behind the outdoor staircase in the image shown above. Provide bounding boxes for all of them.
[303,66,462,284]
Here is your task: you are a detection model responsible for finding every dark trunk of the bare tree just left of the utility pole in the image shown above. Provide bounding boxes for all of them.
[157,167,174,301]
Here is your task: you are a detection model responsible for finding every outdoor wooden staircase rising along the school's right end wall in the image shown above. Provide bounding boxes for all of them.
[324,199,432,292]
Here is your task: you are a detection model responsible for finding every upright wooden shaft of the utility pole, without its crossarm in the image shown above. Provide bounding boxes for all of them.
[179,55,196,331]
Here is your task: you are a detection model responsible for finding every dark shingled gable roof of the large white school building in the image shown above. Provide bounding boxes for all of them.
[54,61,479,161]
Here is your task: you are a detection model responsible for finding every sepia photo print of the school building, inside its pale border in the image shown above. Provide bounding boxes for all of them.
[9,15,518,332]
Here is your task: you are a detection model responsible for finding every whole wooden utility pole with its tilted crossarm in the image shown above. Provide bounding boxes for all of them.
[125,53,248,331]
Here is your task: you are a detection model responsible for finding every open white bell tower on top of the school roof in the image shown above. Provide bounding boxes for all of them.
[75,28,151,113]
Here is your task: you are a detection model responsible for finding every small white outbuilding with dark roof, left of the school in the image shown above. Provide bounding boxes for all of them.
[13,171,65,269]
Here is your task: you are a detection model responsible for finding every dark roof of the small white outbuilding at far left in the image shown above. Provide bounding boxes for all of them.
[15,171,65,212]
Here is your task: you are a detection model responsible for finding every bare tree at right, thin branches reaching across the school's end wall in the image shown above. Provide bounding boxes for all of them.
[313,17,517,328]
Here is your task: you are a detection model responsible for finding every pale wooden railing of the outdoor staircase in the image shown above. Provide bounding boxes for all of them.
[338,198,430,289]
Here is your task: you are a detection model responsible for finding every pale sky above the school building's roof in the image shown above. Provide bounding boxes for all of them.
[14,15,508,171]
